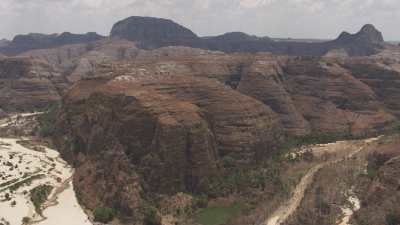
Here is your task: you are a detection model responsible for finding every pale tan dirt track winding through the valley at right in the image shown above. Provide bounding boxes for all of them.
[260,137,380,225]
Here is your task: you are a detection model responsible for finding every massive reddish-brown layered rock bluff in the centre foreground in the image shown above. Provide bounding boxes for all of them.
[56,71,282,216]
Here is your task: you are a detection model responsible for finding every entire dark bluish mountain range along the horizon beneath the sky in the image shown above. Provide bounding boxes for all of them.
[0,16,384,56]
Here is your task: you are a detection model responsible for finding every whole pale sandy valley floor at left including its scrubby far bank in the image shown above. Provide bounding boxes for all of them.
[0,113,92,225]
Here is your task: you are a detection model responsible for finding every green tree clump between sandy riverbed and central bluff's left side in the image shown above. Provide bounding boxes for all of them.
[38,103,60,137]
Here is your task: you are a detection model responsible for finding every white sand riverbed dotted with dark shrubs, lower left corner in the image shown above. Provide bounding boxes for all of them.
[0,138,91,225]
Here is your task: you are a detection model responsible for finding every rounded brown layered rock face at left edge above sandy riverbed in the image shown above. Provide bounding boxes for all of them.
[0,57,69,111]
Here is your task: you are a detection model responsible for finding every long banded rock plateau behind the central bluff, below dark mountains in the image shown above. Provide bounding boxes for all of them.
[3,40,400,135]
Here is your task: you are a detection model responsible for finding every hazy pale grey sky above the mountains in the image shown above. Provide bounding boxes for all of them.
[0,0,400,40]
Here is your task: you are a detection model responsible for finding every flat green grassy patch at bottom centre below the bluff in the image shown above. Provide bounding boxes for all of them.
[195,203,242,225]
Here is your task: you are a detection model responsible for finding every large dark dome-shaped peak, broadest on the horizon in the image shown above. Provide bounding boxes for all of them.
[111,16,198,46]
